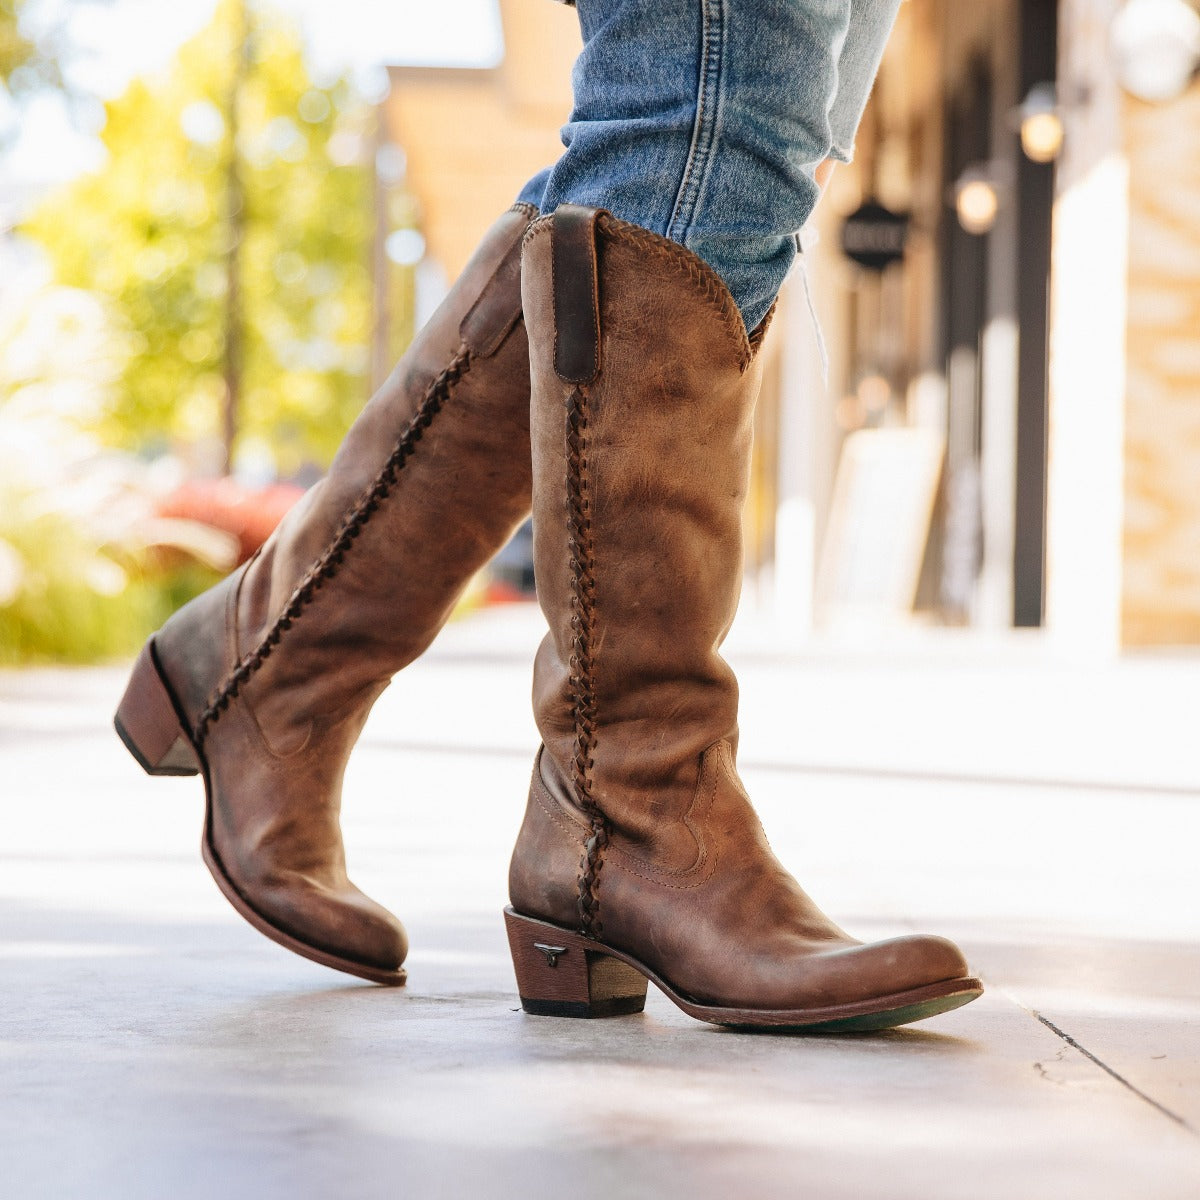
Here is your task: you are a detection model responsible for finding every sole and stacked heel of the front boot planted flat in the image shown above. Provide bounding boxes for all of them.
[504,907,983,1033]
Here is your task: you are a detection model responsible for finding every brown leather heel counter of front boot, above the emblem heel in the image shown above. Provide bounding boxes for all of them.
[509,750,589,928]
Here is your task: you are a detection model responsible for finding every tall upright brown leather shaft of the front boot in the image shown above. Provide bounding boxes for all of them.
[524,206,760,866]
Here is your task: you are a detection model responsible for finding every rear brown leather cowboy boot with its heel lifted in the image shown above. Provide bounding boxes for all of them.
[116,205,535,984]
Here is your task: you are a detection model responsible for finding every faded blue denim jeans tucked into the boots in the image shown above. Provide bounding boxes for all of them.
[521,0,900,329]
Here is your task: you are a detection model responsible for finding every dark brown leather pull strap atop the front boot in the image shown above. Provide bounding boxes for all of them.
[552,204,604,384]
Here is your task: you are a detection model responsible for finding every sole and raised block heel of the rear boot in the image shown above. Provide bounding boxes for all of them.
[113,637,408,988]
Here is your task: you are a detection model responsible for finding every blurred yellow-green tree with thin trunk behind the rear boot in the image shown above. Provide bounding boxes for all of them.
[24,0,372,474]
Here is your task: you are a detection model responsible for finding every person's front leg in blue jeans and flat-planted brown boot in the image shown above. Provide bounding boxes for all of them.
[506,0,982,1030]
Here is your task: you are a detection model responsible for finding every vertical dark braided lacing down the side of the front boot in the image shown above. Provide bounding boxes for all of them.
[566,388,608,937]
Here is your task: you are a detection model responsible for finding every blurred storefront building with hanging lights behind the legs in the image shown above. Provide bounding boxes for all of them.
[377,0,1200,653]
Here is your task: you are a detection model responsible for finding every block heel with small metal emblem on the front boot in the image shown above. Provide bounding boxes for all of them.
[504,908,646,1016]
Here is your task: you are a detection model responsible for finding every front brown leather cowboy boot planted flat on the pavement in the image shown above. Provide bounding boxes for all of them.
[506,205,982,1030]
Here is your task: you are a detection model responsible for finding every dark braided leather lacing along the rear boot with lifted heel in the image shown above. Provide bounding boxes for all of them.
[192,347,470,746]
